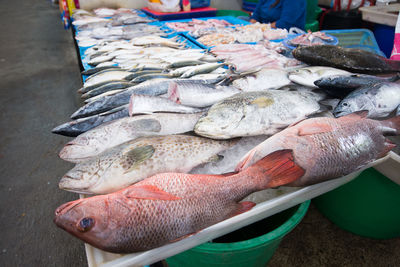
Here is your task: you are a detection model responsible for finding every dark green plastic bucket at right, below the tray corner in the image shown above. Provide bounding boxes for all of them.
[313,168,400,239]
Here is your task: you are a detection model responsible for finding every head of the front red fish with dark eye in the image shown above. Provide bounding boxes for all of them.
[53,196,114,251]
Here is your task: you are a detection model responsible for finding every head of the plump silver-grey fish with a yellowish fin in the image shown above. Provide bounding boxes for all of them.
[194,104,245,139]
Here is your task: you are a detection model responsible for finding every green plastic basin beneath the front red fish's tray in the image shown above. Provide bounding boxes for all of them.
[166,201,310,267]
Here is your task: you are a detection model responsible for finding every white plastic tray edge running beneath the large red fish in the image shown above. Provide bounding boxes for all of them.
[81,152,400,267]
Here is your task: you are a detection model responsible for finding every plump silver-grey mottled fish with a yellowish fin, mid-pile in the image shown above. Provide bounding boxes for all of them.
[194,90,323,139]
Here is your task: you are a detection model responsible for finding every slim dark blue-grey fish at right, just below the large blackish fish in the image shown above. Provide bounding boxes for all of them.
[314,74,400,99]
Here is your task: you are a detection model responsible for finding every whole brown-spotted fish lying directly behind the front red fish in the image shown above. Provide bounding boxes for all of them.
[59,135,238,194]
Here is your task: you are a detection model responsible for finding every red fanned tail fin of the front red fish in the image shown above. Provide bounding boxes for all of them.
[244,149,305,190]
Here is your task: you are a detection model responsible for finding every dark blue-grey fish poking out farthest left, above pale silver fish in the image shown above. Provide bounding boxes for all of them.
[51,105,129,137]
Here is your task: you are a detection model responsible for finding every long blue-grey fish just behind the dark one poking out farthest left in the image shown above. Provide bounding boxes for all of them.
[71,80,173,119]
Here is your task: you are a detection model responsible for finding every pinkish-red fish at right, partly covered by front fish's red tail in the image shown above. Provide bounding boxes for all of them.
[236,111,400,186]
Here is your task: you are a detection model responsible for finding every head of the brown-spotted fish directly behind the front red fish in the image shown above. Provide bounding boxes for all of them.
[58,158,113,194]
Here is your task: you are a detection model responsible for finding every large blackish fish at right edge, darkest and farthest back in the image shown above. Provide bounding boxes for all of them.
[292,45,400,74]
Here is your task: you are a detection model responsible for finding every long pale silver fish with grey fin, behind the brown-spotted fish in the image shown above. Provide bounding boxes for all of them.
[59,113,203,162]
